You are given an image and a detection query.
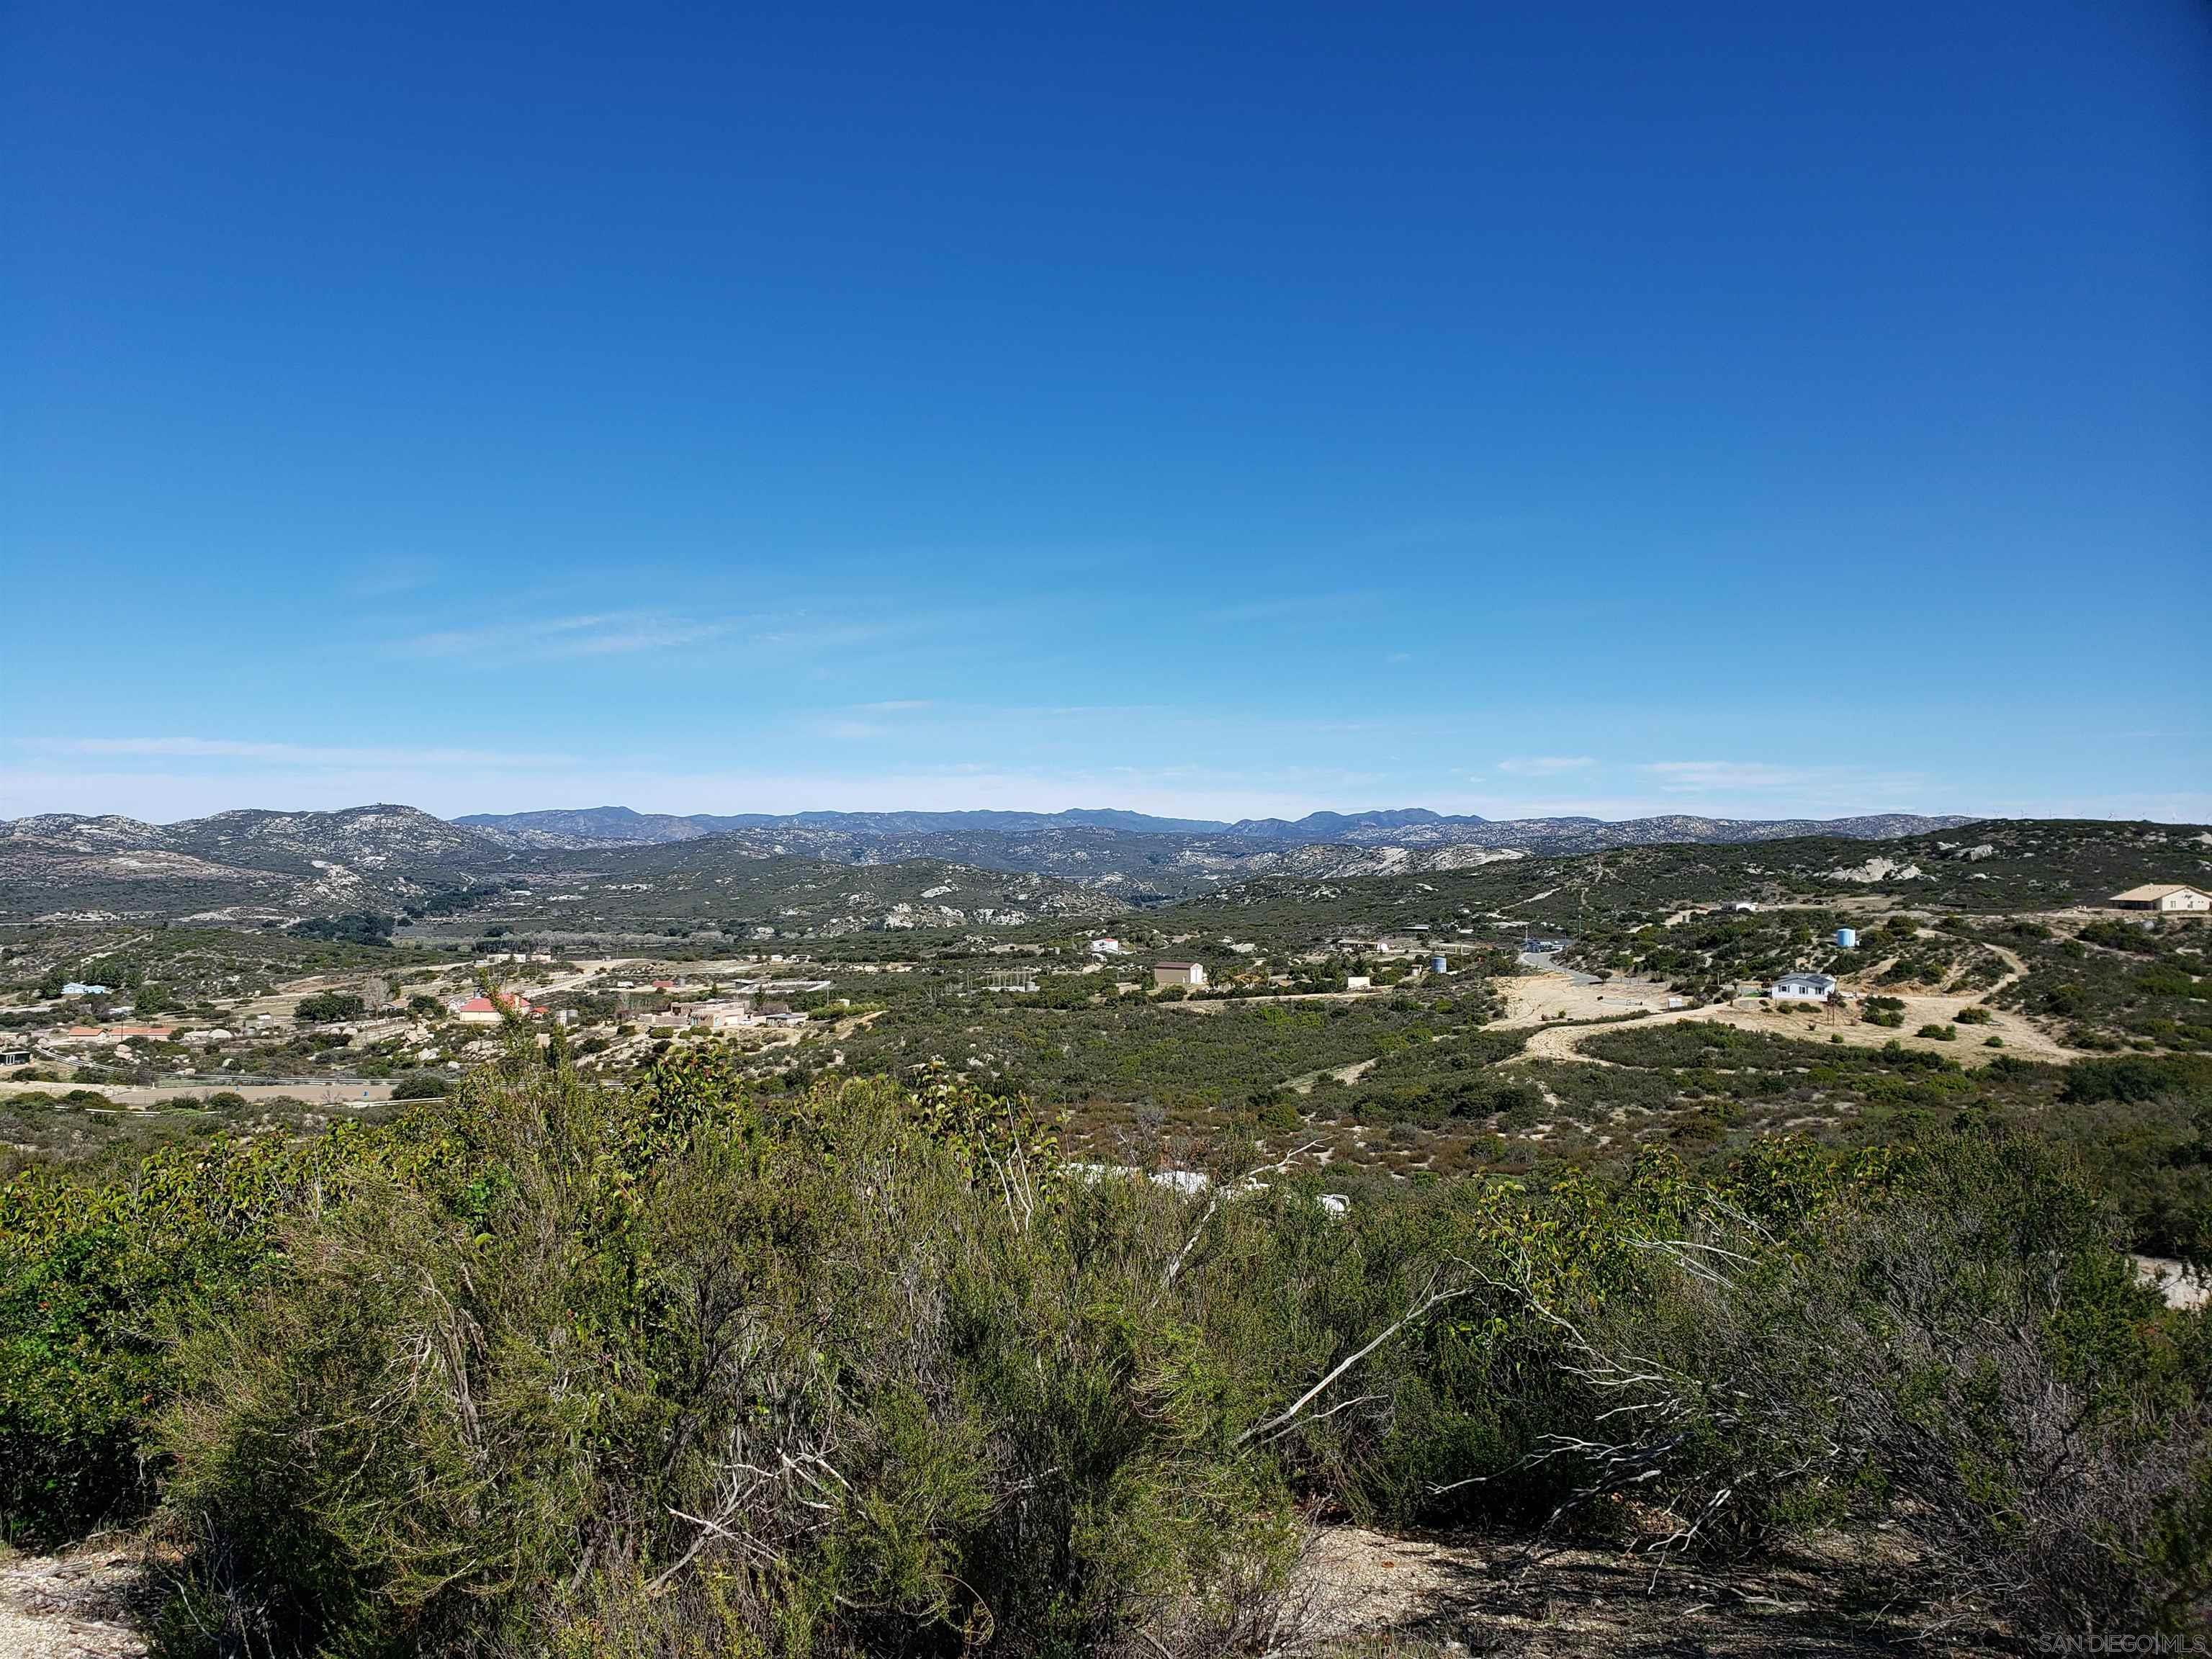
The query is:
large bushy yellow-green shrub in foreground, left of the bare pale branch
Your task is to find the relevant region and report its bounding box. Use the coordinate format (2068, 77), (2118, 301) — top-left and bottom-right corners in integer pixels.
(161, 1062), (1294, 1655)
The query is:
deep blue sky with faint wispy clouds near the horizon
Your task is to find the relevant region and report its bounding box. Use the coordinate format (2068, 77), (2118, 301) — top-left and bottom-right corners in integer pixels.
(0, 0), (2212, 819)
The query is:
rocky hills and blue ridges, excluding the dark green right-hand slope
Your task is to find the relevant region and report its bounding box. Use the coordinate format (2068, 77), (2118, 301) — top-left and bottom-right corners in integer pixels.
(0, 805), (1966, 922)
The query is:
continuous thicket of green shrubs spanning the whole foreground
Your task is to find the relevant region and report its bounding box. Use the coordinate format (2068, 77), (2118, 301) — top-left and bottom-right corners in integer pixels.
(0, 1043), (2212, 1659)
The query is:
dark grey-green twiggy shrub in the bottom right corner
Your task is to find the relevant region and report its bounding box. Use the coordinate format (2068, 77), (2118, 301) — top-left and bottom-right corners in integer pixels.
(1513, 1135), (2212, 1630)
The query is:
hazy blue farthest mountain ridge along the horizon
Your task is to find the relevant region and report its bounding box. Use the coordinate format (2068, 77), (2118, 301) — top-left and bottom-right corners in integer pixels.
(454, 807), (1969, 850)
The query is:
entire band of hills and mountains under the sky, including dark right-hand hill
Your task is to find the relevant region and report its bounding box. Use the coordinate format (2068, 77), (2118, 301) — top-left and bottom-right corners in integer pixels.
(0, 805), (2212, 938)
